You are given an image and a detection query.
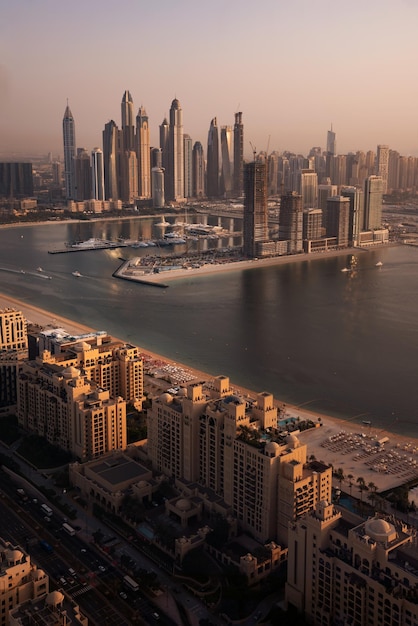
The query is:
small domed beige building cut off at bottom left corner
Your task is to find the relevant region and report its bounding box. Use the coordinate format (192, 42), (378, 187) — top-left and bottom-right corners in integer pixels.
(0, 539), (49, 626)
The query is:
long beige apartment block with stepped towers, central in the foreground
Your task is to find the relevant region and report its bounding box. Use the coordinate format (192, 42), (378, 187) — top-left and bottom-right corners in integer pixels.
(147, 376), (332, 545)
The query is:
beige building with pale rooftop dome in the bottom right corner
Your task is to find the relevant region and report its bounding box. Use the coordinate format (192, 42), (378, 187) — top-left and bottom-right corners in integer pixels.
(286, 501), (418, 626)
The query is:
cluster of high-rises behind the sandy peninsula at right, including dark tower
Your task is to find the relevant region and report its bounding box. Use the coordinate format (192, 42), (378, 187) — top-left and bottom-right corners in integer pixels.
(243, 131), (389, 257)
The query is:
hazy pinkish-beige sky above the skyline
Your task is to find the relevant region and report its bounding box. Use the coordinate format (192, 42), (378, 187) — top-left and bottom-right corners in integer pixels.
(0, 0), (418, 158)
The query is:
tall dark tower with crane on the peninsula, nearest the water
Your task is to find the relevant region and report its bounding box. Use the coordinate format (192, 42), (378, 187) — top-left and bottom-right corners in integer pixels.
(243, 161), (268, 258)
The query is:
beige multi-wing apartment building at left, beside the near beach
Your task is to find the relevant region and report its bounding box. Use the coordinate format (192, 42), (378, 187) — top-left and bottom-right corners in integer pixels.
(17, 330), (144, 461)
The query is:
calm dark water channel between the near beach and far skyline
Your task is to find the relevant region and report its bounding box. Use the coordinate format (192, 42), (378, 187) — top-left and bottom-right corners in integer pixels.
(0, 217), (418, 437)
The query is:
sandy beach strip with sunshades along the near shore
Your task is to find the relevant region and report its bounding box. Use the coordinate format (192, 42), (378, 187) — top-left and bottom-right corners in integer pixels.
(0, 294), (418, 494)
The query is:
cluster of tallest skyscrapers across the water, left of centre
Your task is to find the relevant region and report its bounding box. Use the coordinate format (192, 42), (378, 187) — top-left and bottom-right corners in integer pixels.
(63, 91), (244, 207)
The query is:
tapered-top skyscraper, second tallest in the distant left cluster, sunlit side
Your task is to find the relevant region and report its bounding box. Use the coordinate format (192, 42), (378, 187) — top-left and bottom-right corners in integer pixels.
(167, 98), (184, 202)
